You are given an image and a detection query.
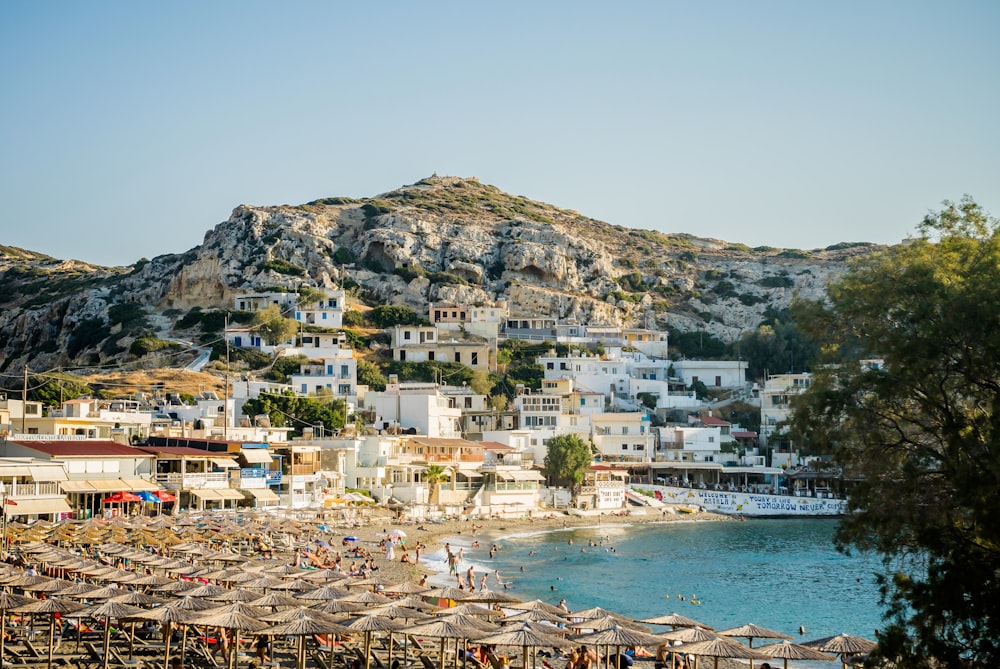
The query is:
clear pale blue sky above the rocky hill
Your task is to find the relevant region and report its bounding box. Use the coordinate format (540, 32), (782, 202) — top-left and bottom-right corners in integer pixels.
(0, 0), (1000, 264)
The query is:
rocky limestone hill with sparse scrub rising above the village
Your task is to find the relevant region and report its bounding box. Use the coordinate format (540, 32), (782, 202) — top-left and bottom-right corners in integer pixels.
(0, 175), (874, 373)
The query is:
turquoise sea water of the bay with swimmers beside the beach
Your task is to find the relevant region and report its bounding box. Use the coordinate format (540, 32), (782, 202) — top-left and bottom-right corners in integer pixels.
(435, 519), (881, 645)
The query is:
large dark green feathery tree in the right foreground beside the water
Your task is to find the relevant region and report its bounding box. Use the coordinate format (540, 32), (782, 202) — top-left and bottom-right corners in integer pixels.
(794, 198), (1000, 667)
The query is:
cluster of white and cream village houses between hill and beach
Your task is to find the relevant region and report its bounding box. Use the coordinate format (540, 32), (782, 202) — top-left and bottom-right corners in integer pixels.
(0, 290), (795, 517)
